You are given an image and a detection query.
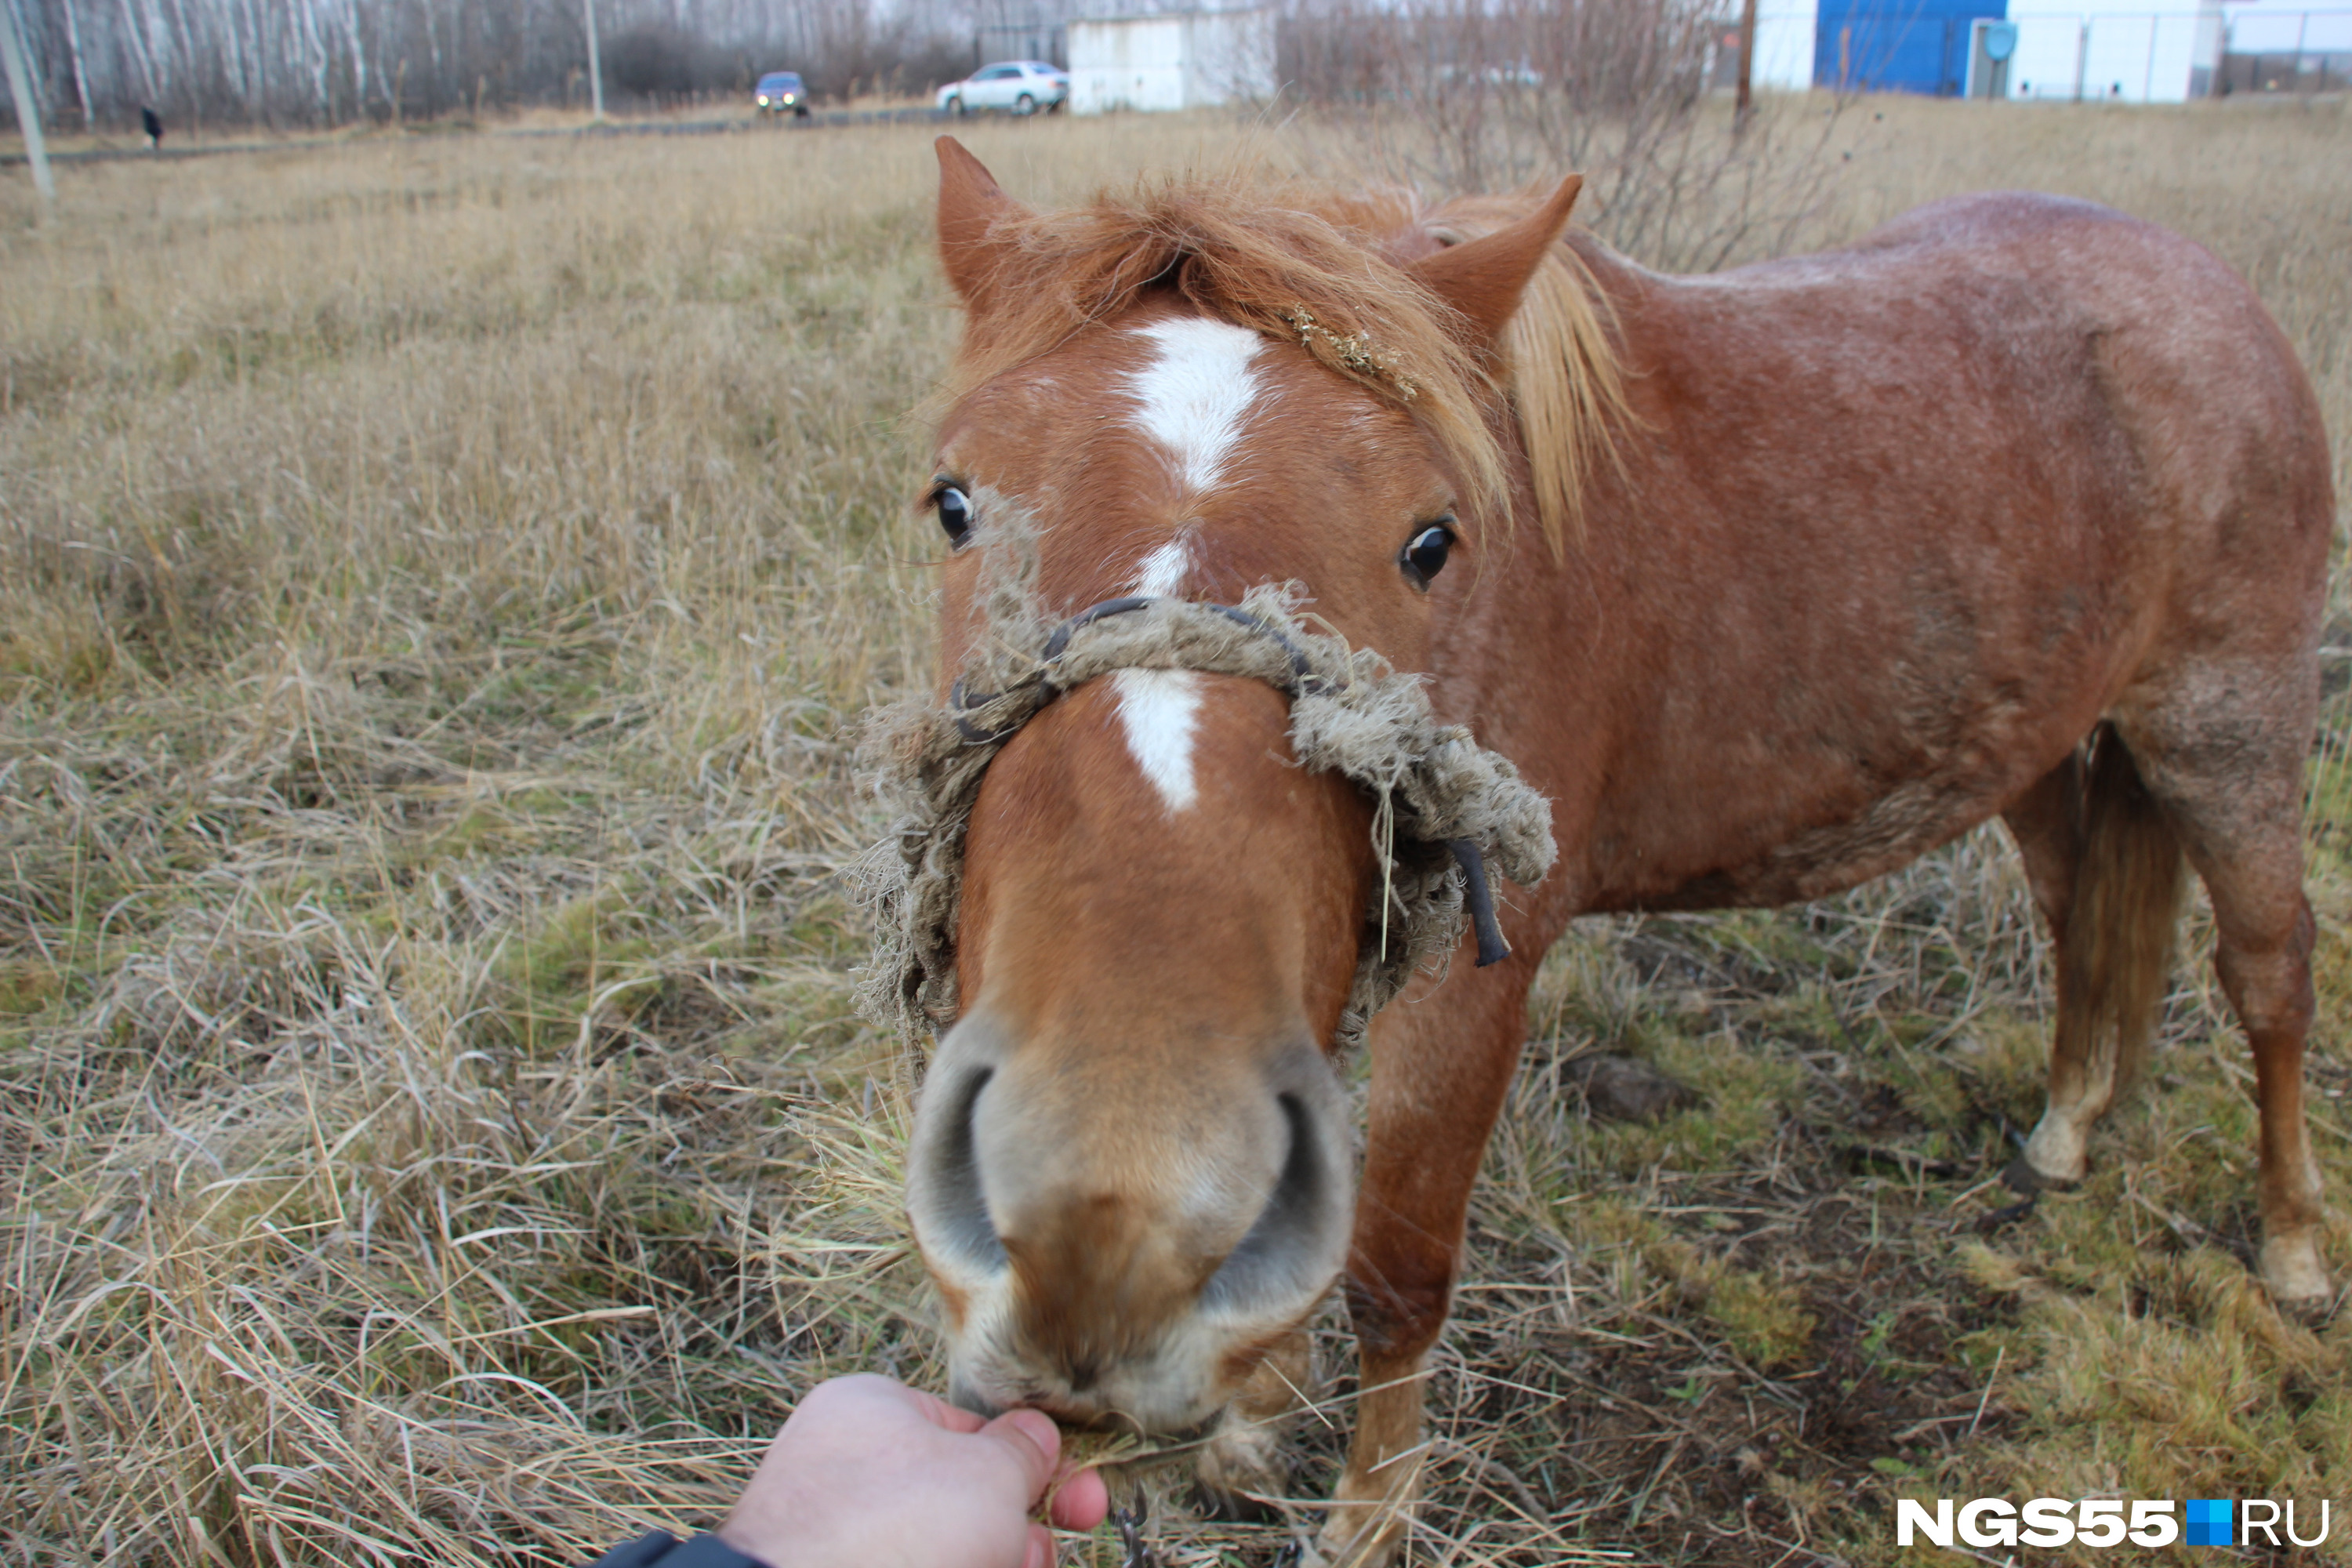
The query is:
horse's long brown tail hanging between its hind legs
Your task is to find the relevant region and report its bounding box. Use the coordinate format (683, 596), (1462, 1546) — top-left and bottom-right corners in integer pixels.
(2058, 724), (2185, 1093)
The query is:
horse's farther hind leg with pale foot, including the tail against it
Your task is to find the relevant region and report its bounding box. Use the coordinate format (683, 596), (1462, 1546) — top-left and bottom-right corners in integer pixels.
(2004, 727), (2183, 1189)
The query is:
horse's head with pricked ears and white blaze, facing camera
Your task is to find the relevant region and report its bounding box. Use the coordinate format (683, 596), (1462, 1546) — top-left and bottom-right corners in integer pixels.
(889, 139), (1576, 1432)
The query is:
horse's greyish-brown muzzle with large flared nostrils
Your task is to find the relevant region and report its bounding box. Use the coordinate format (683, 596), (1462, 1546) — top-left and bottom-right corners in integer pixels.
(908, 1011), (1352, 1434)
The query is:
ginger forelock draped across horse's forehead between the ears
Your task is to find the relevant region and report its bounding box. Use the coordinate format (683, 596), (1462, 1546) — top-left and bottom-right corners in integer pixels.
(943, 183), (1510, 535)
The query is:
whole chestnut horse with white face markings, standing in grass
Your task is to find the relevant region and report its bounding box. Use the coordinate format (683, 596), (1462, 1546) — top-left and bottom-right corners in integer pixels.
(884, 139), (2333, 1561)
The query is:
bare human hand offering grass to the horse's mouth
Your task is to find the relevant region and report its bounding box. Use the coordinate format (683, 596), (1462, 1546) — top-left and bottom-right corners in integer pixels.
(720, 1373), (1110, 1568)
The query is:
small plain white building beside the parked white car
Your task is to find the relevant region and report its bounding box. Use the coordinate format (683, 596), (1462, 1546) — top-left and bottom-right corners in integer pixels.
(1068, 9), (1277, 115)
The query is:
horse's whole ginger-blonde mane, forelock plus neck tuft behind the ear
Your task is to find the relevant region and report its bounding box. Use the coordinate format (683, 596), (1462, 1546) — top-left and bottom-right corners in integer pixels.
(943, 183), (1623, 550)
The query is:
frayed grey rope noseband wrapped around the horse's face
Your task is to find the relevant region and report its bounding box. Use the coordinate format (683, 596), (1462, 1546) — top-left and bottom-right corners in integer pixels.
(849, 496), (1555, 1048)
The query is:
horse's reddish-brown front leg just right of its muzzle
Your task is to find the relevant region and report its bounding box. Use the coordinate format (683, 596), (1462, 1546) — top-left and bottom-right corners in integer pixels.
(1317, 942), (1543, 1568)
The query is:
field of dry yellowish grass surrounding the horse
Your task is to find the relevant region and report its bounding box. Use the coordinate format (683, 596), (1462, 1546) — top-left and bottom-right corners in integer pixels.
(0, 101), (2352, 1568)
